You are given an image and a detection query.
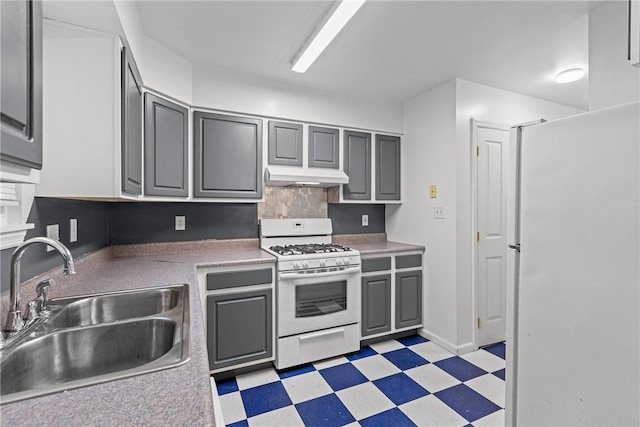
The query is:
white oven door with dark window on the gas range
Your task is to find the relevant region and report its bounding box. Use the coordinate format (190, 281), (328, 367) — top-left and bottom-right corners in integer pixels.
(278, 266), (361, 337)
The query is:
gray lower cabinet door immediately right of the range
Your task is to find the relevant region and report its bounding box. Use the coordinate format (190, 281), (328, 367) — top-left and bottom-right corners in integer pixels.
(362, 274), (391, 337)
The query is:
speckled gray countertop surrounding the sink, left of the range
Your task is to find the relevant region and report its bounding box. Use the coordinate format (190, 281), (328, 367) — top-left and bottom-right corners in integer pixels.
(0, 239), (275, 426)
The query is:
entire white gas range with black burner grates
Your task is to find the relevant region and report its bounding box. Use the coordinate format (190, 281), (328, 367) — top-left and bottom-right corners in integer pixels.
(260, 218), (361, 369)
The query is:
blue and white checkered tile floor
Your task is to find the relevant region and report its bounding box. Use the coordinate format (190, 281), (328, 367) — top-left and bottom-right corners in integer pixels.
(211, 335), (505, 427)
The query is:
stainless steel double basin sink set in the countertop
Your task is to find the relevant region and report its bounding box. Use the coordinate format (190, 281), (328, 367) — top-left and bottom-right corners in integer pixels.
(0, 285), (190, 404)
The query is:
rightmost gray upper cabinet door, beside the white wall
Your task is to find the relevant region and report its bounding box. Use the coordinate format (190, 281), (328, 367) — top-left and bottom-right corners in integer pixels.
(376, 135), (400, 200)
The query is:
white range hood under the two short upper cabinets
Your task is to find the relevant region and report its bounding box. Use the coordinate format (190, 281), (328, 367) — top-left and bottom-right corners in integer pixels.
(264, 166), (349, 187)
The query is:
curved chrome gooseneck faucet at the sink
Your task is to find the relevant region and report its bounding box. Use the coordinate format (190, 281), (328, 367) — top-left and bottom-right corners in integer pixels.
(2, 237), (76, 335)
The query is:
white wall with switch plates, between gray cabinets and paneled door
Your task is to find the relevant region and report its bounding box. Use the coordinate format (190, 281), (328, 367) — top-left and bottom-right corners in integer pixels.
(387, 79), (580, 352)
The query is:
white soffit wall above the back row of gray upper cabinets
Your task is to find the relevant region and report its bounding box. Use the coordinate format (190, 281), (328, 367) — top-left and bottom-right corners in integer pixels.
(193, 64), (403, 133)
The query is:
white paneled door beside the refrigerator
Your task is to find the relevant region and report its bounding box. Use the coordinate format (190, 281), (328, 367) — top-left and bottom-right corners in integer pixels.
(475, 125), (509, 346)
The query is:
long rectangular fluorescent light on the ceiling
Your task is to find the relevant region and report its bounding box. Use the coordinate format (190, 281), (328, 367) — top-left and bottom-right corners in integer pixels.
(291, 0), (365, 73)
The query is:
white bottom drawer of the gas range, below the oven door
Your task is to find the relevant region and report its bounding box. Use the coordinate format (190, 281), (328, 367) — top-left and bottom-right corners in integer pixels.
(276, 323), (360, 369)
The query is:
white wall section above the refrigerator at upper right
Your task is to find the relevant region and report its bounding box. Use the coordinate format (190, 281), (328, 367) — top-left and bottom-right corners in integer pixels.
(589, 1), (640, 111)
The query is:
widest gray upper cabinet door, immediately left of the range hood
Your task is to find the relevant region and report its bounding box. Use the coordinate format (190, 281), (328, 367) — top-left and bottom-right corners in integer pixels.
(193, 111), (262, 199)
